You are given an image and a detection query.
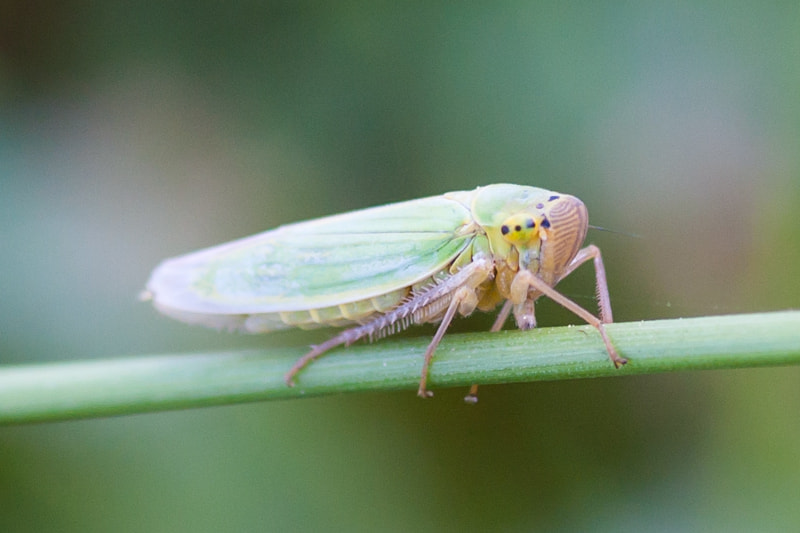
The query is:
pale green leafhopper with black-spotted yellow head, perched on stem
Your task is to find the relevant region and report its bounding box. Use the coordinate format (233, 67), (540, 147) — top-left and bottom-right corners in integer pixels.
(146, 184), (626, 402)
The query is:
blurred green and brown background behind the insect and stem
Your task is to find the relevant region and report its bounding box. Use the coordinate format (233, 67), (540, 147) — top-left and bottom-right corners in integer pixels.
(0, 1), (800, 532)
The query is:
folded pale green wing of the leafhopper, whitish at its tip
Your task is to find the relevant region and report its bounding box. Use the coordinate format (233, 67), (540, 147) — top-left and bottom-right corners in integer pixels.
(147, 196), (474, 314)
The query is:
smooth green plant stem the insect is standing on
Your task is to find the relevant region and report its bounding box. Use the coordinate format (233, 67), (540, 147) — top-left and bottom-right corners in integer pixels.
(0, 311), (800, 423)
